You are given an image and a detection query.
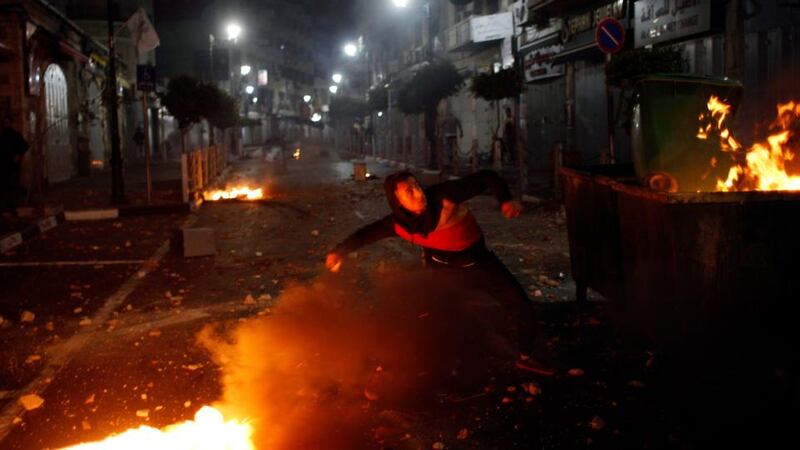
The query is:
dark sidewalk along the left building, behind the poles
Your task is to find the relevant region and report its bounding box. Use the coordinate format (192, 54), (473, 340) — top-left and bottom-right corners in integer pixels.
(30, 161), (182, 211)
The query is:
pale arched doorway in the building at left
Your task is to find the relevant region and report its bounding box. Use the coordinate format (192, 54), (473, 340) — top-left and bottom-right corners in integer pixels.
(44, 64), (74, 183)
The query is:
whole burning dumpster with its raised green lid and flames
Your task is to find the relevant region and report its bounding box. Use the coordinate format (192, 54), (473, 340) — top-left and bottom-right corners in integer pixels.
(562, 79), (800, 367)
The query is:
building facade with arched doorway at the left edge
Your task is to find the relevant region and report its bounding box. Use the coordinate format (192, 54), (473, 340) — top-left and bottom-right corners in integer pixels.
(0, 0), (108, 192)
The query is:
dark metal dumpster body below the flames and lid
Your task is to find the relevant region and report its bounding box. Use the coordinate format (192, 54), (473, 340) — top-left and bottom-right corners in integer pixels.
(562, 167), (800, 367)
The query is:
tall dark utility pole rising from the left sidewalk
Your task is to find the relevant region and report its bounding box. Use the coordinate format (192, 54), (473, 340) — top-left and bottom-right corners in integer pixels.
(106, 0), (125, 205)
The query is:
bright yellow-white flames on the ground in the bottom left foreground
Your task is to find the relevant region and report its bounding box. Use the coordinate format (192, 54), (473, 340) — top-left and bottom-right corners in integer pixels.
(63, 406), (255, 450)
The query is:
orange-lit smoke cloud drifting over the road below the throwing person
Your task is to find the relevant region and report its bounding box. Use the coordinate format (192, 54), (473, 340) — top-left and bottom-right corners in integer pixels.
(198, 270), (513, 450)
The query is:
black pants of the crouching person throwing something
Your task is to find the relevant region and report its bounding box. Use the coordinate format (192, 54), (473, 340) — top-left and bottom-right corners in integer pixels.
(425, 247), (541, 355)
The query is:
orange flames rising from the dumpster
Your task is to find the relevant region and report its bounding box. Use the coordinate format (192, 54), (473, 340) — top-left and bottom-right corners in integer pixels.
(697, 96), (800, 192)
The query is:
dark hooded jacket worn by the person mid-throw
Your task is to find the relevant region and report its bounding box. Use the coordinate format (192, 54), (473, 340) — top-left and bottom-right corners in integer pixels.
(333, 170), (512, 255)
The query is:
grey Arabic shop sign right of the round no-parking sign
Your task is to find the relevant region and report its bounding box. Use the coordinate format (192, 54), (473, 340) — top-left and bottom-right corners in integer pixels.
(633, 0), (711, 48)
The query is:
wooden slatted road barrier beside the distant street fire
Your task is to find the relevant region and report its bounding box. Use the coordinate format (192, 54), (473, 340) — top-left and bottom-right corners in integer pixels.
(181, 145), (228, 203)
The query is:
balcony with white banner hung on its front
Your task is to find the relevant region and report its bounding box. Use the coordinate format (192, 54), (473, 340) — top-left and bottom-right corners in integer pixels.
(445, 12), (514, 52)
